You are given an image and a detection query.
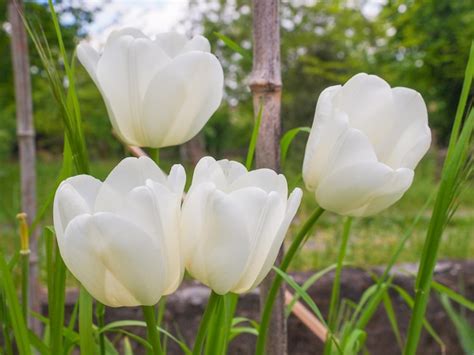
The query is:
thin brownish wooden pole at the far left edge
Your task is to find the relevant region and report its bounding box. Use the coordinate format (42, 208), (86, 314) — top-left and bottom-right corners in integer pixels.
(8, 0), (40, 333)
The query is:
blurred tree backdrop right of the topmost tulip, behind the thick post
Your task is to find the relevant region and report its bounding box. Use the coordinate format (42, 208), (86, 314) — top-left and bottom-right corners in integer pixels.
(185, 0), (474, 156)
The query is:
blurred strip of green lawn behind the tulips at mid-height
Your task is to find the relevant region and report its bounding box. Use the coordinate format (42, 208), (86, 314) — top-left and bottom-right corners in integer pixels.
(0, 149), (474, 270)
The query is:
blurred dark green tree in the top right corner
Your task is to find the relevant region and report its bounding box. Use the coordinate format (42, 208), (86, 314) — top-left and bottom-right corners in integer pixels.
(374, 0), (474, 143)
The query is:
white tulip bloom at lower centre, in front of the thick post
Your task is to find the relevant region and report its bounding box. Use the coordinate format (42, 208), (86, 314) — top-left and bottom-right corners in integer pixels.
(181, 157), (302, 294)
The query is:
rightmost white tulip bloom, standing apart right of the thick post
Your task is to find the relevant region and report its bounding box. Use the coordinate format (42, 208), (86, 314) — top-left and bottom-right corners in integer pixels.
(303, 74), (431, 216)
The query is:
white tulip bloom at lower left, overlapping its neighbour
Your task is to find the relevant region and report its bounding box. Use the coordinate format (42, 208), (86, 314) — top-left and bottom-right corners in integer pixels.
(54, 157), (186, 307)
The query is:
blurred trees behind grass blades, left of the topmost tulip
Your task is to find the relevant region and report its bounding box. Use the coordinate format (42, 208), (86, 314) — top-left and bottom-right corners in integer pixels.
(0, 0), (117, 158)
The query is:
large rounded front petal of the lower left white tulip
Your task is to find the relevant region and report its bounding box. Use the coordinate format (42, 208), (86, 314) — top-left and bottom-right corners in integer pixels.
(61, 213), (167, 307)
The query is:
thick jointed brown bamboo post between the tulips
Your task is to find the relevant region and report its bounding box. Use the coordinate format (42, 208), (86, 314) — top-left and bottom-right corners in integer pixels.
(250, 0), (287, 355)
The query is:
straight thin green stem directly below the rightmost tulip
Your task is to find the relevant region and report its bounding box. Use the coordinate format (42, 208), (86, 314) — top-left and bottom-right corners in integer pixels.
(324, 217), (352, 354)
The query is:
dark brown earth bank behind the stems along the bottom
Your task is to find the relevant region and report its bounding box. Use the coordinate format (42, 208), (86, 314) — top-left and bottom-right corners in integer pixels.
(40, 261), (474, 355)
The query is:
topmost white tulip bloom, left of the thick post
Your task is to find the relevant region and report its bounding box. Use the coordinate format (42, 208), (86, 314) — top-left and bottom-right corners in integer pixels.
(77, 28), (224, 148)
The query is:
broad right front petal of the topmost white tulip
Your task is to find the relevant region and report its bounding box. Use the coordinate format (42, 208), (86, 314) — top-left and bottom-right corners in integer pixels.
(143, 52), (224, 147)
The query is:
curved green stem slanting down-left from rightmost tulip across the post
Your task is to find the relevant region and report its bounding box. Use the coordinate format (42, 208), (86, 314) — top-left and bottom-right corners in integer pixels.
(255, 207), (324, 355)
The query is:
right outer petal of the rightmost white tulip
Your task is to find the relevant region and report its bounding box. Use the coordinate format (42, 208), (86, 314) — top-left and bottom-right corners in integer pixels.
(385, 88), (431, 169)
